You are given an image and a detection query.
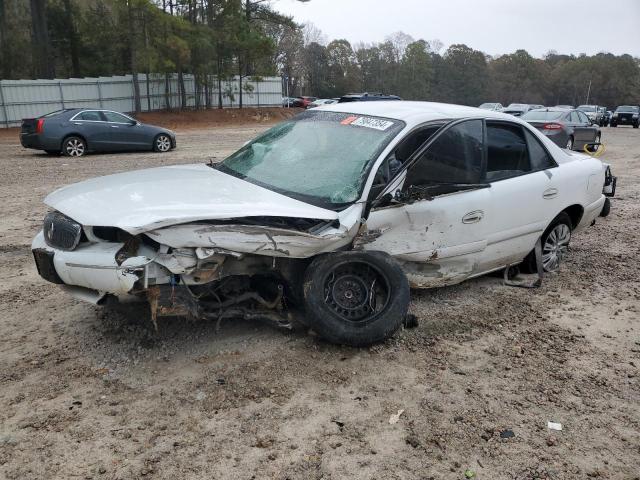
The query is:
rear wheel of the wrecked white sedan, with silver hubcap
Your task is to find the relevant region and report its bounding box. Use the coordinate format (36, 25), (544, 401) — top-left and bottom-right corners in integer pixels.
(520, 212), (573, 273)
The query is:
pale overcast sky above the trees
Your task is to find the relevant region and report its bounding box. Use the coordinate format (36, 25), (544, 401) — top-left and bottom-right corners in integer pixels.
(272, 0), (640, 57)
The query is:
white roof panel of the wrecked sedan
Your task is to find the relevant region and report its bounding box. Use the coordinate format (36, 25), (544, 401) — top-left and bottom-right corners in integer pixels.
(318, 100), (514, 126)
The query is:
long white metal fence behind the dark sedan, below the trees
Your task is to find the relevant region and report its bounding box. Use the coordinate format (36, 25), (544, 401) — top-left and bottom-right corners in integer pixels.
(0, 74), (282, 127)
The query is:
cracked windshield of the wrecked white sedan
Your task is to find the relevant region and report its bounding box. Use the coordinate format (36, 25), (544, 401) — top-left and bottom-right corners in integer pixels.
(218, 112), (404, 206)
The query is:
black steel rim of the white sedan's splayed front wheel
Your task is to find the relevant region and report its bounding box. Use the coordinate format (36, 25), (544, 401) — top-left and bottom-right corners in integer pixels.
(323, 261), (391, 323)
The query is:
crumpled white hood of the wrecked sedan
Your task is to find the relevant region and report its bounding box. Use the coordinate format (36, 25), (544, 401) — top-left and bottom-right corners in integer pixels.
(44, 164), (338, 234)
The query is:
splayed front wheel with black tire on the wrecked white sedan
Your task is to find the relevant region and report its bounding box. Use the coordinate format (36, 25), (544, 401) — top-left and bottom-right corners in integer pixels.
(304, 252), (410, 347)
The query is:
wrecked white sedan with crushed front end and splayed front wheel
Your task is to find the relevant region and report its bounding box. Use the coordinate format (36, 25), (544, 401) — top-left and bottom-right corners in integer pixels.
(32, 102), (612, 345)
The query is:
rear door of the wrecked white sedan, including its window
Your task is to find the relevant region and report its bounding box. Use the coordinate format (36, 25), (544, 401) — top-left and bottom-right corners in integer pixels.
(480, 121), (561, 272)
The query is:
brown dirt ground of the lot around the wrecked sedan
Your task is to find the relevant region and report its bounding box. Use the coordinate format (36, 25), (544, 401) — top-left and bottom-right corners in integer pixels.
(0, 115), (640, 480)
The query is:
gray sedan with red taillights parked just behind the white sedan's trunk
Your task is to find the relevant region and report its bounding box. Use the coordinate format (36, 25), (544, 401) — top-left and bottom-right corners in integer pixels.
(520, 108), (602, 150)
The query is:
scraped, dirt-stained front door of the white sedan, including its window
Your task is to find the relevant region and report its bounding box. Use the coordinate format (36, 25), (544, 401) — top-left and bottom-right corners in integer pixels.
(363, 119), (489, 287)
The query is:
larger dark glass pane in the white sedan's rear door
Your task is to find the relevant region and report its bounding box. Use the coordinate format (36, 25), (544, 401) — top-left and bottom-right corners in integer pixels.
(486, 124), (531, 182)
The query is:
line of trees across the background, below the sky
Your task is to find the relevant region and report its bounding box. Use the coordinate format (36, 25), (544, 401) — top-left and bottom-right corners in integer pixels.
(0, 0), (640, 108)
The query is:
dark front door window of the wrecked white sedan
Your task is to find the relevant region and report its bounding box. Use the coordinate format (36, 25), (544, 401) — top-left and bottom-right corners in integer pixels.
(405, 120), (483, 186)
